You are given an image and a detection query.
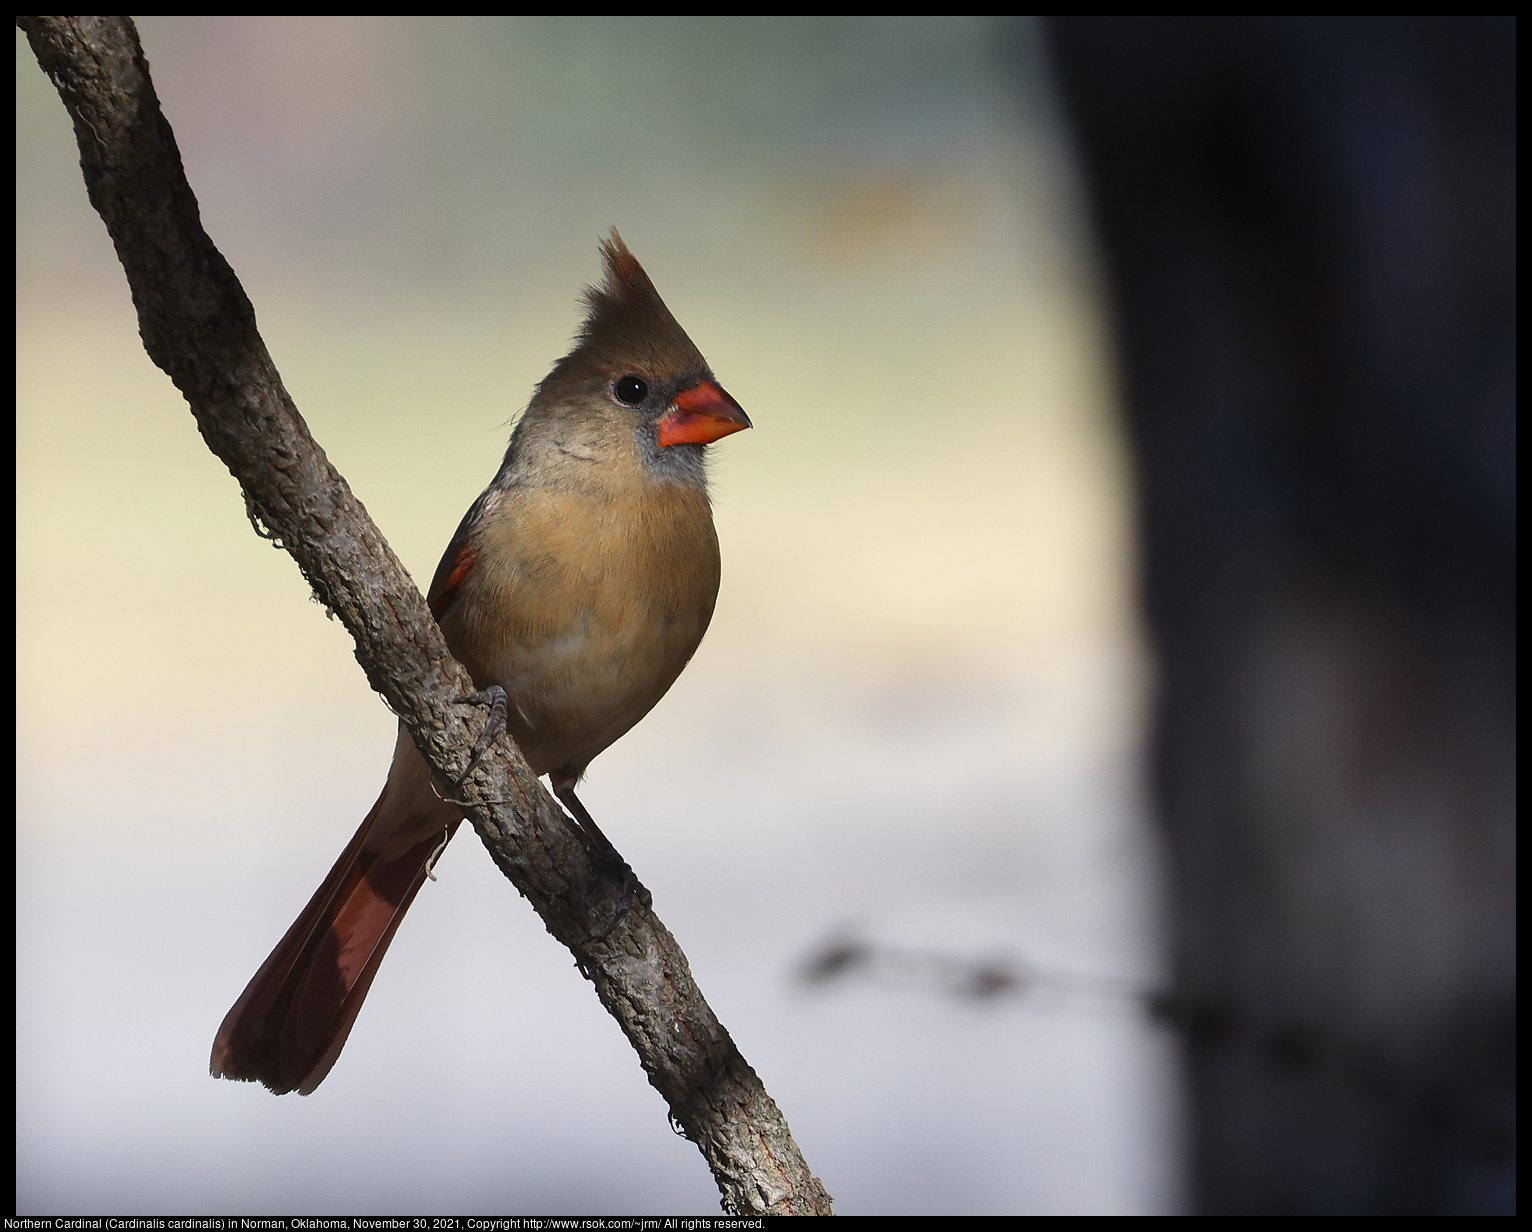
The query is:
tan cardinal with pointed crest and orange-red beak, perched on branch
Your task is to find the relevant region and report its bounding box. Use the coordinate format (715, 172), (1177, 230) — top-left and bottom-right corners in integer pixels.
(211, 230), (751, 1096)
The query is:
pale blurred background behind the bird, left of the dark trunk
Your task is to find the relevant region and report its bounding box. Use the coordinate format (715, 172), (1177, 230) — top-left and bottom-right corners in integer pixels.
(17, 17), (1184, 1215)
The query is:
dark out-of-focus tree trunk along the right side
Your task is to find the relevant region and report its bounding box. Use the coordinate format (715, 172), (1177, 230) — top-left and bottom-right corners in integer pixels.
(1048, 18), (1515, 1215)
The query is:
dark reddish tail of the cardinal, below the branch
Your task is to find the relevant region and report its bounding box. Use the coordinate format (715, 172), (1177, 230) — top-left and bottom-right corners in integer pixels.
(211, 788), (461, 1096)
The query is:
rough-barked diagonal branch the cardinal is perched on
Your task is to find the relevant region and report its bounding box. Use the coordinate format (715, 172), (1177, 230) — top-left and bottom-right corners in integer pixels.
(17, 17), (830, 1214)
